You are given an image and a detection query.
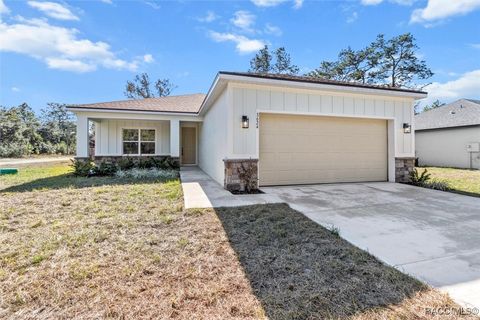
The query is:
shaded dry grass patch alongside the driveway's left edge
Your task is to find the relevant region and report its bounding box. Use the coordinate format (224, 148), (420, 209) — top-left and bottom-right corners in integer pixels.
(217, 204), (473, 320)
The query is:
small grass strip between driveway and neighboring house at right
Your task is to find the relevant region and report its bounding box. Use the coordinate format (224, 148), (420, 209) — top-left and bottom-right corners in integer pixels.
(418, 167), (480, 197)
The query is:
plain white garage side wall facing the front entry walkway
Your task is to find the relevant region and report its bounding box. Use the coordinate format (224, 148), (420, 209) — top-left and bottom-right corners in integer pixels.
(198, 90), (230, 185)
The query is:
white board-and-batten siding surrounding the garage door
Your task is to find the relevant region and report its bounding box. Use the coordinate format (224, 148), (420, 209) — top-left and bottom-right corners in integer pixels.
(229, 83), (414, 158)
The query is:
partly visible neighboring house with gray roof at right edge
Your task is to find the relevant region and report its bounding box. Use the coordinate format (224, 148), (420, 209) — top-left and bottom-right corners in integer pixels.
(415, 99), (480, 169)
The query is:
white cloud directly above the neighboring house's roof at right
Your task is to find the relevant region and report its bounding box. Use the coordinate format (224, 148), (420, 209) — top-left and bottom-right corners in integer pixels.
(421, 69), (480, 105)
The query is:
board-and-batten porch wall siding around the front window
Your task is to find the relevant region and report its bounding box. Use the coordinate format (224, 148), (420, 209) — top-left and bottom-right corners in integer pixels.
(95, 119), (170, 156)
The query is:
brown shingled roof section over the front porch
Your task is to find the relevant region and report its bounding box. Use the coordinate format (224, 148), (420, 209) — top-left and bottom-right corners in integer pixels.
(68, 93), (205, 114)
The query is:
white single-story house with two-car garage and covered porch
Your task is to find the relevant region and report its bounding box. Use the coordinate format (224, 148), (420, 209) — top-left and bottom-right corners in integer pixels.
(69, 72), (427, 190)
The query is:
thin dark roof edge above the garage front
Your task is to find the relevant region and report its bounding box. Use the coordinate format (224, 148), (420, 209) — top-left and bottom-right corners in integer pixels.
(219, 71), (427, 94)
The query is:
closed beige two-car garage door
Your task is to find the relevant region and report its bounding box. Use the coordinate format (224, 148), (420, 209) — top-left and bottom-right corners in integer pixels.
(259, 114), (387, 186)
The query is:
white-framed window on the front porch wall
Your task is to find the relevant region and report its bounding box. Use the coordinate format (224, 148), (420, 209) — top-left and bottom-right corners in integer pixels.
(122, 129), (155, 154)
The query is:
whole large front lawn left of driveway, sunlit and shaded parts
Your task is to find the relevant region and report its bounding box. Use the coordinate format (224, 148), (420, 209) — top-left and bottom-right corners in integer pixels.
(0, 164), (471, 320)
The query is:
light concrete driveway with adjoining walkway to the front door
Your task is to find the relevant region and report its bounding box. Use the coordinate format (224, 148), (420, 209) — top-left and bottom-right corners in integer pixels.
(181, 168), (480, 308)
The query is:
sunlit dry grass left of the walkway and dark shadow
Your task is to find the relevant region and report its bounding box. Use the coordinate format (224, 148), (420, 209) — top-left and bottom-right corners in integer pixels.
(0, 167), (262, 319)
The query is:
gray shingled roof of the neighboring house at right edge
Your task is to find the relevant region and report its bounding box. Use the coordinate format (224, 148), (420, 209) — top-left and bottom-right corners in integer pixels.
(415, 99), (480, 130)
